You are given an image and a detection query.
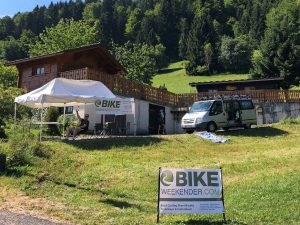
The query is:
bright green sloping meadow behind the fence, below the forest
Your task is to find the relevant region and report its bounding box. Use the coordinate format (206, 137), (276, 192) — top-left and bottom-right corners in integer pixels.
(152, 61), (249, 93)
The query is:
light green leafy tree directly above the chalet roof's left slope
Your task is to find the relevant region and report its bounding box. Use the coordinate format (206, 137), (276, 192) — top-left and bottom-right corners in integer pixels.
(29, 19), (97, 56)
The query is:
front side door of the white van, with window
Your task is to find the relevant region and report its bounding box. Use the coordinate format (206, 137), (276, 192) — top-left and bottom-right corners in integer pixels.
(209, 101), (227, 127)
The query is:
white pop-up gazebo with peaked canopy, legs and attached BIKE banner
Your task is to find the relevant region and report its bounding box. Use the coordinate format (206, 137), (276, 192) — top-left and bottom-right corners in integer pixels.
(15, 78), (134, 140)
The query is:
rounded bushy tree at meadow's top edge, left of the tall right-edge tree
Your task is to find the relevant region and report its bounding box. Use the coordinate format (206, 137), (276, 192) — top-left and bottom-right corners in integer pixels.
(219, 36), (251, 72)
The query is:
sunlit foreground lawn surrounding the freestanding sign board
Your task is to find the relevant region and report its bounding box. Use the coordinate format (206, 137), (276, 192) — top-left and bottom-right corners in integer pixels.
(0, 120), (300, 225)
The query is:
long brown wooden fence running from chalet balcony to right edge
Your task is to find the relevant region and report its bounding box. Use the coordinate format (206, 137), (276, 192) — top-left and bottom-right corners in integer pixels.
(60, 68), (300, 107)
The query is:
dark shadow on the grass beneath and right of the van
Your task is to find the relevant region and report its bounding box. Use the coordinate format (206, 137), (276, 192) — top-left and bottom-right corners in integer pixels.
(218, 127), (288, 137)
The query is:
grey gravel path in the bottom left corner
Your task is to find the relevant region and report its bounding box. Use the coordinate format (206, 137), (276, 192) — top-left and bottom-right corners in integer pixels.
(0, 210), (66, 225)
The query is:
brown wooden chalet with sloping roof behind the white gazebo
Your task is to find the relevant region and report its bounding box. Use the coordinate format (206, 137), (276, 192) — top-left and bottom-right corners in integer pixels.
(8, 44), (126, 91)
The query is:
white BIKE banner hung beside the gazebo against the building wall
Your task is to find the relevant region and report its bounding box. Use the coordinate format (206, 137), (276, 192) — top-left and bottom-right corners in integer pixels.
(95, 98), (134, 115)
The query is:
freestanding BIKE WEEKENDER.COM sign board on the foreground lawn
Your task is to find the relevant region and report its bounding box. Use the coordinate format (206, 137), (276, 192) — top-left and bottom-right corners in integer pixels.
(158, 168), (224, 214)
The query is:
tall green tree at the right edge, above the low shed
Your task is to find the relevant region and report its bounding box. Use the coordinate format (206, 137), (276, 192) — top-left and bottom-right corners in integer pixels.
(251, 0), (300, 87)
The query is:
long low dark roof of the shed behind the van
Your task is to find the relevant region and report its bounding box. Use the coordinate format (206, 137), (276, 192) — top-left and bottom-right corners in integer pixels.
(189, 77), (284, 87)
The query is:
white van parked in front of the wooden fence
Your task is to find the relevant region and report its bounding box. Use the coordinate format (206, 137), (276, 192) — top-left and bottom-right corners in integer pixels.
(181, 97), (256, 133)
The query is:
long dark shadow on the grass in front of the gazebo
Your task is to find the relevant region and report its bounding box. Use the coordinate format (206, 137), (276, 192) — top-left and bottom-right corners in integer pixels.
(65, 137), (162, 151)
